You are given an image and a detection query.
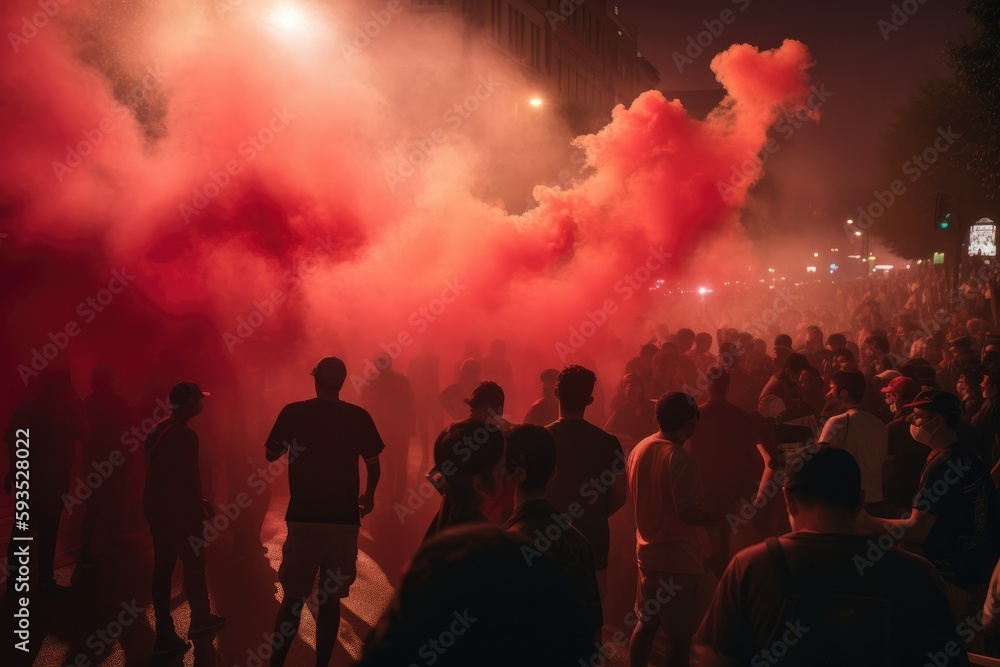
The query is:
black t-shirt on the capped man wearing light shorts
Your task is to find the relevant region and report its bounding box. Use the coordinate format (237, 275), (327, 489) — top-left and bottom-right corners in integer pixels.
(265, 398), (385, 526)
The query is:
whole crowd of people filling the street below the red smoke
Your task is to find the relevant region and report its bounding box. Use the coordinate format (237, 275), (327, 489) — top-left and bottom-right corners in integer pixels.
(5, 271), (1000, 667)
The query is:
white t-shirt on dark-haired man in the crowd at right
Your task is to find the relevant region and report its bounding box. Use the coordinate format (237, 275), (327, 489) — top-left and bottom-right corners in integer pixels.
(819, 408), (889, 503)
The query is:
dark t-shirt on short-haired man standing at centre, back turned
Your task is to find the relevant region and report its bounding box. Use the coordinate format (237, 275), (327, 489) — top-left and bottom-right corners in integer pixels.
(546, 419), (625, 570)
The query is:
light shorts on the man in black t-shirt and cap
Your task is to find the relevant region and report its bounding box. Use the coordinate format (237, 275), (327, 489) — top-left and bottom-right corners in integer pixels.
(278, 521), (358, 600)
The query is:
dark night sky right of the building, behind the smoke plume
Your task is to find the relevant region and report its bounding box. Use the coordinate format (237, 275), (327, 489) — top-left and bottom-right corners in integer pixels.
(619, 0), (971, 239)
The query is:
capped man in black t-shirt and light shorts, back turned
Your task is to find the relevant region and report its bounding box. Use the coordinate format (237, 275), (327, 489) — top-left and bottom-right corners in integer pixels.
(265, 357), (385, 667)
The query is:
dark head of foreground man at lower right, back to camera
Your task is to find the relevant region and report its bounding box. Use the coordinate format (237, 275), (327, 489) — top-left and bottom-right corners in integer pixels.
(784, 447), (864, 532)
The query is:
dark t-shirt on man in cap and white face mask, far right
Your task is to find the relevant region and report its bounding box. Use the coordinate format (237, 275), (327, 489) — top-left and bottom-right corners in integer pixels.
(913, 442), (1000, 586)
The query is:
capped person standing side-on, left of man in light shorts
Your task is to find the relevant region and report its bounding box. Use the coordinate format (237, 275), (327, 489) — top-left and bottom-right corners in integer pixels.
(142, 382), (226, 655)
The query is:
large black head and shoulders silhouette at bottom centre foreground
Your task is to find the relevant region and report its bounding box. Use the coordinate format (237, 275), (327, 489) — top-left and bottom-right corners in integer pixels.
(357, 525), (596, 667)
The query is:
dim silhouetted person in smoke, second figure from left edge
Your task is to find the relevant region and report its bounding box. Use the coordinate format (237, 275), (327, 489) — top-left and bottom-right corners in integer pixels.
(80, 365), (132, 567)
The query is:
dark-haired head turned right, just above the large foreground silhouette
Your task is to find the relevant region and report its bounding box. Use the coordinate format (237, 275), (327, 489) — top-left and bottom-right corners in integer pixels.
(434, 419), (506, 508)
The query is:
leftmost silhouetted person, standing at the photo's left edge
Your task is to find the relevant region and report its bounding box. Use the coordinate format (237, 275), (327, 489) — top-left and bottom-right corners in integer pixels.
(4, 370), (88, 596)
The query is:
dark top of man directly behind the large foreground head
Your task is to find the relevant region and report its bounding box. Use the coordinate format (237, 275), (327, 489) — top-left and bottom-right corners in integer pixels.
(504, 499), (604, 632)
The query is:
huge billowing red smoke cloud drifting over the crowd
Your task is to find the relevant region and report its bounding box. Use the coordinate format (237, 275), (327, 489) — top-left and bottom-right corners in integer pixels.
(0, 0), (811, 421)
